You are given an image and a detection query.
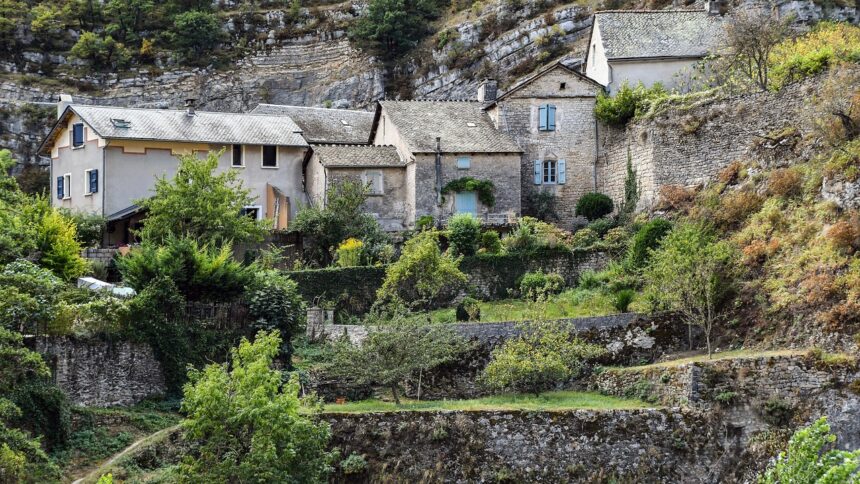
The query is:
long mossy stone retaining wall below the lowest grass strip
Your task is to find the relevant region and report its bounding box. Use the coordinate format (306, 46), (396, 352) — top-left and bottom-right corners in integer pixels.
(324, 409), (744, 483)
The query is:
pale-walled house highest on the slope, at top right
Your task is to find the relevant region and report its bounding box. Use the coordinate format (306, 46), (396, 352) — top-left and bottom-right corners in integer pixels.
(584, 1), (725, 94)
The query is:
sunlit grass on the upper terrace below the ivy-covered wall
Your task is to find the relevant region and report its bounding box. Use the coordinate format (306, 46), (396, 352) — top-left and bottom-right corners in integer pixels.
(430, 288), (645, 323)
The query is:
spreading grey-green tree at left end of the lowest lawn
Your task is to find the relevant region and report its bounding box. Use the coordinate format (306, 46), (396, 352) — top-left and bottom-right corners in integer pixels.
(327, 313), (470, 405)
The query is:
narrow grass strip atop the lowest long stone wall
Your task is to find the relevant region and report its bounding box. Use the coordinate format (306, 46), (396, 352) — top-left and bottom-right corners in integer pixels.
(325, 391), (654, 413)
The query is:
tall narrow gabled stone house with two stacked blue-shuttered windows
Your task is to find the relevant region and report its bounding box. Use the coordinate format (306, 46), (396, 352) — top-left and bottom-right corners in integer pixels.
(488, 62), (603, 226)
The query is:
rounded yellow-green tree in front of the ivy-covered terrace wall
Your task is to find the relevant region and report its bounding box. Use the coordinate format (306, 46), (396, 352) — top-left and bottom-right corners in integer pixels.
(377, 230), (467, 308)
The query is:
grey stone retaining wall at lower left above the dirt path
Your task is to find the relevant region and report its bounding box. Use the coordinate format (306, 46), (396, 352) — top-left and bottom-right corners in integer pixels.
(28, 337), (165, 407)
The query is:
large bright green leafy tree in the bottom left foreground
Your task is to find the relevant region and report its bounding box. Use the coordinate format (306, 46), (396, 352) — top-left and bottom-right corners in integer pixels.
(179, 331), (333, 482)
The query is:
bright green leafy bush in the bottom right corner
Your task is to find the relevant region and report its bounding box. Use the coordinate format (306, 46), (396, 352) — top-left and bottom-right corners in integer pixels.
(758, 417), (860, 484)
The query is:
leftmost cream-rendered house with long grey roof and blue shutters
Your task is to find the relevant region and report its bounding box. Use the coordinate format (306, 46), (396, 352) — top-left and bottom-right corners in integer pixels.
(39, 100), (308, 245)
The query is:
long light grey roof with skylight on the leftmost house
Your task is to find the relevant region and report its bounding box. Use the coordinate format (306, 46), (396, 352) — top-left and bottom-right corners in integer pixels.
(69, 104), (308, 146)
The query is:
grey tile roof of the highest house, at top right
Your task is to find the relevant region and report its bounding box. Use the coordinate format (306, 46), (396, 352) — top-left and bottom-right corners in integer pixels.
(594, 10), (724, 59)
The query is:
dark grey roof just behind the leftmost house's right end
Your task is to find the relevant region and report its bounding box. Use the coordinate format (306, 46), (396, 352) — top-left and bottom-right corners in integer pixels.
(251, 104), (373, 144)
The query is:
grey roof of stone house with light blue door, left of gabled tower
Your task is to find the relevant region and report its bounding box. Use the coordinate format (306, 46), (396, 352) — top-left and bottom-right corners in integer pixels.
(379, 101), (522, 153)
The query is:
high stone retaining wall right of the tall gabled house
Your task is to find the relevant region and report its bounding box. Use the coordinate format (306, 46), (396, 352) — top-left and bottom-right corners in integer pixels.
(597, 78), (821, 210)
